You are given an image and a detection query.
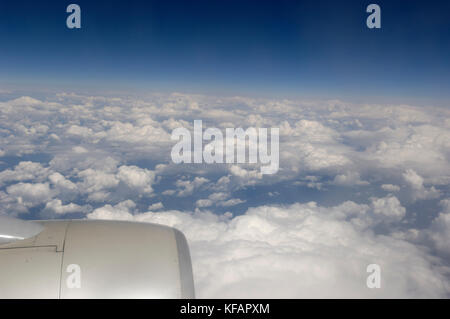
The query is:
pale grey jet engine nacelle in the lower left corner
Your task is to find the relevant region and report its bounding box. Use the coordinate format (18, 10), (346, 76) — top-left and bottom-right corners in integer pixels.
(0, 220), (194, 299)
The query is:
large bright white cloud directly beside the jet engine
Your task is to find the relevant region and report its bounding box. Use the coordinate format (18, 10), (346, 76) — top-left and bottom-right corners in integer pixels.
(89, 199), (450, 298)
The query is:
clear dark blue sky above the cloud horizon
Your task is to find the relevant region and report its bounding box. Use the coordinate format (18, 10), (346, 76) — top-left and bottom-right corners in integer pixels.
(0, 0), (450, 100)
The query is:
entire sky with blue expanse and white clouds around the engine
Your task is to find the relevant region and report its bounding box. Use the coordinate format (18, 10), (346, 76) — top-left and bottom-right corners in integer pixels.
(0, 1), (450, 298)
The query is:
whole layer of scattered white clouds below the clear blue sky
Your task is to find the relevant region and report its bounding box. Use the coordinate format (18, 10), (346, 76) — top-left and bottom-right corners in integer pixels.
(0, 93), (450, 298)
